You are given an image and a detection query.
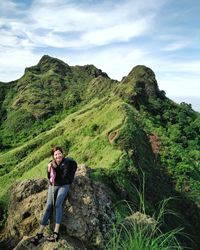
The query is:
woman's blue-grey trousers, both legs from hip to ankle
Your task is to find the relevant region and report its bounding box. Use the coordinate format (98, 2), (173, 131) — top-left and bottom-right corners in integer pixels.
(41, 185), (69, 226)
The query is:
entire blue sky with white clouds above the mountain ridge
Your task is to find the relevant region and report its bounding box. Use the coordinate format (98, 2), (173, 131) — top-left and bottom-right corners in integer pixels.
(0, 0), (200, 111)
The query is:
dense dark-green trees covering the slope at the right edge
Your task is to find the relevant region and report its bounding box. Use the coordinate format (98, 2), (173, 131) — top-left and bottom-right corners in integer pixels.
(143, 95), (200, 199)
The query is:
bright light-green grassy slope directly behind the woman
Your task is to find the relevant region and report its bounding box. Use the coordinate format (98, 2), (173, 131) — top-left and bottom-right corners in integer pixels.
(0, 94), (124, 196)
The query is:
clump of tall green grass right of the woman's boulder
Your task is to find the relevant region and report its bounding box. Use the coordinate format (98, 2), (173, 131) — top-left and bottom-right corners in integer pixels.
(105, 180), (186, 250)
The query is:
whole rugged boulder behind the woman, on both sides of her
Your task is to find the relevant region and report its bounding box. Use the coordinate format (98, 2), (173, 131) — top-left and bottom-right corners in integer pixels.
(0, 165), (115, 250)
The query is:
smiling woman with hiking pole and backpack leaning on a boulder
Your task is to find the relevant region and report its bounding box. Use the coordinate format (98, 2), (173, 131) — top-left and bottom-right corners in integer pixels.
(31, 147), (77, 245)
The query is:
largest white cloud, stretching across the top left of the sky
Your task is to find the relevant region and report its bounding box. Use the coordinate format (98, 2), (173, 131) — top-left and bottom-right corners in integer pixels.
(0, 0), (164, 48)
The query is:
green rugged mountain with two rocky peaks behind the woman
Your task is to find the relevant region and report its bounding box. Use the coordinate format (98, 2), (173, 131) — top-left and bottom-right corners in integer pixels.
(0, 55), (200, 249)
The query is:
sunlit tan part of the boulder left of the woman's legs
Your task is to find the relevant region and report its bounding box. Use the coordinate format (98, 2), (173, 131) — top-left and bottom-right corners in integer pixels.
(5, 179), (48, 249)
